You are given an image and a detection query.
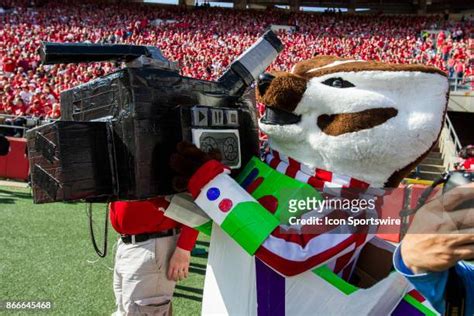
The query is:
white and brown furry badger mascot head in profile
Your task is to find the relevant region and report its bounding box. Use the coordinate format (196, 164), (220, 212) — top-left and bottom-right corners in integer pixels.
(257, 56), (449, 187)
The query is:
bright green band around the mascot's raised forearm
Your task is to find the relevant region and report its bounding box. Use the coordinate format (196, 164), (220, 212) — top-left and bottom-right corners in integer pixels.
(221, 202), (280, 255)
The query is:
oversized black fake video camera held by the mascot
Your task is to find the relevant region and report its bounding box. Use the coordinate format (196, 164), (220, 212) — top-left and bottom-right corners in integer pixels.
(27, 31), (282, 203)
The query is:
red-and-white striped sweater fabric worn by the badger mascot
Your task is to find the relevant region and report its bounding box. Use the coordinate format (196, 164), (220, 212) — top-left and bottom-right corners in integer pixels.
(255, 150), (383, 279)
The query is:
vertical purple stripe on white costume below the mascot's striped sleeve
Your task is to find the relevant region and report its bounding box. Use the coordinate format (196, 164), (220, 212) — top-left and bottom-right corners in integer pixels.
(255, 258), (285, 316)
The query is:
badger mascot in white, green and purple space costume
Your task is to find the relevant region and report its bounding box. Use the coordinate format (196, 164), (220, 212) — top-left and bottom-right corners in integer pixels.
(167, 56), (448, 316)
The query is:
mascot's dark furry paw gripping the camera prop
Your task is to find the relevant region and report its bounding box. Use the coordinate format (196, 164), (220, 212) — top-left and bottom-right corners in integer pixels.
(170, 141), (222, 192)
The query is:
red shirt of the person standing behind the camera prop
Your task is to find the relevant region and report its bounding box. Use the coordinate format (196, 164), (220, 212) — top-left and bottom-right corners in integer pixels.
(110, 197), (198, 251)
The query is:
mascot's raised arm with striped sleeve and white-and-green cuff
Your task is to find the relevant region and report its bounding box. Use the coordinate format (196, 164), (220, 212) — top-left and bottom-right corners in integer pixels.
(188, 160), (367, 276)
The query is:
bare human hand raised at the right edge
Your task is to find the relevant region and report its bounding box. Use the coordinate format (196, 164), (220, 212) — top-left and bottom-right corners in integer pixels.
(400, 183), (474, 274)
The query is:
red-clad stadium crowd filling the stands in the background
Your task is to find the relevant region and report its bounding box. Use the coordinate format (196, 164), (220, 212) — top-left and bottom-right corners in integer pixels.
(0, 1), (474, 124)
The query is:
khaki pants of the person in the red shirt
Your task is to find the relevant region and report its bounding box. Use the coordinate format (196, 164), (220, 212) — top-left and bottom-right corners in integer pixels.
(113, 235), (178, 316)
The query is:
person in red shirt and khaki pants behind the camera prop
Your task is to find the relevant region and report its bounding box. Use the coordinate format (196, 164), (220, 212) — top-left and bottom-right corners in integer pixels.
(110, 197), (198, 316)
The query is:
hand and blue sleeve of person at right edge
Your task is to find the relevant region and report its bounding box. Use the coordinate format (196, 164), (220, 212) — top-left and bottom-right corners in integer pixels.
(394, 183), (474, 315)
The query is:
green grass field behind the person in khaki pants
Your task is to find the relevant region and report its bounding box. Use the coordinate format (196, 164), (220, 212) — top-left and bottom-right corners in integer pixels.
(0, 186), (208, 315)
